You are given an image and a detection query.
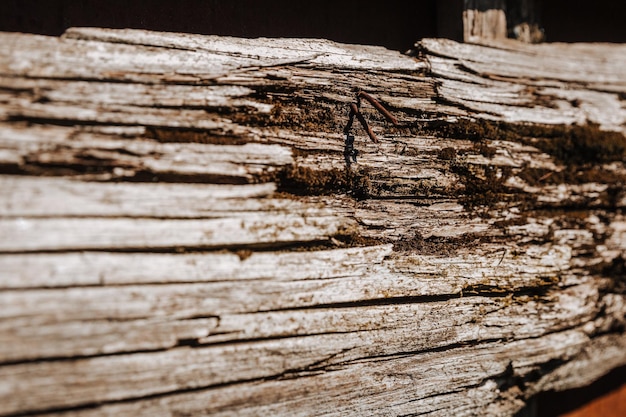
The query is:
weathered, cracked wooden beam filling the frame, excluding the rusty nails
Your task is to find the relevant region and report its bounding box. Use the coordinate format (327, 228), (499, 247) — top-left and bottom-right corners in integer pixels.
(0, 28), (626, 416)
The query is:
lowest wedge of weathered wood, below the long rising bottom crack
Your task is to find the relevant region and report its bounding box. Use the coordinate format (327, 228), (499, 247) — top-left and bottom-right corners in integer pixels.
(22, 330), (624, 415)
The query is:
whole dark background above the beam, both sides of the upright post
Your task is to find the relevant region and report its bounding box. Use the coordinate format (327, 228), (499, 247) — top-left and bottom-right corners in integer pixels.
(0, 0), (626, 51)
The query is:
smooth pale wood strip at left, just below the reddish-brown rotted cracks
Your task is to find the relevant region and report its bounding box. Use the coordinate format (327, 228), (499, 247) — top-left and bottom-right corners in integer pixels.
(0, 175), (310, 219)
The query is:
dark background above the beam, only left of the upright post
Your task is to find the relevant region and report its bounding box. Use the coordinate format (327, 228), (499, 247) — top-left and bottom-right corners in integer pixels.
(0, 0), (437, 50)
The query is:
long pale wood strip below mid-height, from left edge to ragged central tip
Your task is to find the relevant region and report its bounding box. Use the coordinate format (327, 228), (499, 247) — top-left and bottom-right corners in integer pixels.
(0, 245), (390, 289)
